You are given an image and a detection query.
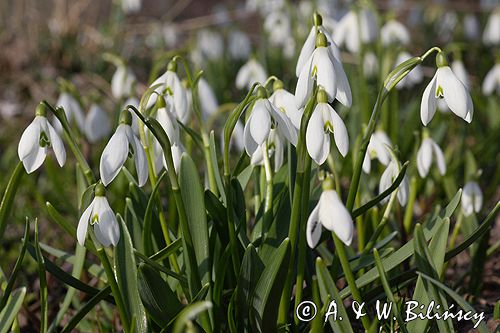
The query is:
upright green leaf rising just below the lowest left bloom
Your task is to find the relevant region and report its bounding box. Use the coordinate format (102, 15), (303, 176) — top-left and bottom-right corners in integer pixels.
(113, 215), (148, 332)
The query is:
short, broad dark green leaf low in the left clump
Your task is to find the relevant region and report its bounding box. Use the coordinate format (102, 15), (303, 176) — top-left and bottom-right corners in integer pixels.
(138, 264), (182, 327)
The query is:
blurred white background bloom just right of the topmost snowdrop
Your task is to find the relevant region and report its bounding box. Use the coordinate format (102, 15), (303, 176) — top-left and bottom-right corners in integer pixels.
(333, 9), (378, 53)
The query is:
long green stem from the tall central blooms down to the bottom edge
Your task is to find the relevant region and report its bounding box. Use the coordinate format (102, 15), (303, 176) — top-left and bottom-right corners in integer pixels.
(278, 88), (318, 326)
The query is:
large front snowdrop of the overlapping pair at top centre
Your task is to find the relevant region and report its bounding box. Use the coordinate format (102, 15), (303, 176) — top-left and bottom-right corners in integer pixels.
(295, 33), (352, 108)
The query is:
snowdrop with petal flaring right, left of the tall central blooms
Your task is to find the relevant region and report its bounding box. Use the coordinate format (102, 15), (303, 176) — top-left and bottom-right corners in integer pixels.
(243, 86), (297, 156)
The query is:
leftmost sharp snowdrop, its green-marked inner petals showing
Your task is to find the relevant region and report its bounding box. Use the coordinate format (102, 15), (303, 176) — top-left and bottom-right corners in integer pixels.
(17, 104), (66, 173)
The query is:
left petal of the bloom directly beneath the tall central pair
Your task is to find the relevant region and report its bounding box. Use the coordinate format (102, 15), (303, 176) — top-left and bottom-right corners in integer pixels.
(306, 103), (330, 165)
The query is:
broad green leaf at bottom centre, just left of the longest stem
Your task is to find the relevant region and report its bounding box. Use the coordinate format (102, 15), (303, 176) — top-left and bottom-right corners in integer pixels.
(251, 238), (290, 331)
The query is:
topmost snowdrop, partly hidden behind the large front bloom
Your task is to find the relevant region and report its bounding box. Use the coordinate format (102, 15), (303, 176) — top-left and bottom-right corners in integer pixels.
(295, 14), (341, 77)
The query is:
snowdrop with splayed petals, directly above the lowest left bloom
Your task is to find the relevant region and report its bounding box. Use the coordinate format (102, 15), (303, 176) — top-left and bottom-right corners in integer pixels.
(99, 110), (148, 187)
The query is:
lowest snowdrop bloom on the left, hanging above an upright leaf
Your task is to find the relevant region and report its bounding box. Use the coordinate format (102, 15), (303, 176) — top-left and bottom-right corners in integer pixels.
(76, 183), (120, 247)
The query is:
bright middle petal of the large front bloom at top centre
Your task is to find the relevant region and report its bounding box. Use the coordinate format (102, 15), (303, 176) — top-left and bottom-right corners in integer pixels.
(312, 47), (337, 103)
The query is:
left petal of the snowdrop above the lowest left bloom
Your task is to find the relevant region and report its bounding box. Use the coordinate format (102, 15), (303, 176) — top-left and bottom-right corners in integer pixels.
(99, 124), (128, 186)
